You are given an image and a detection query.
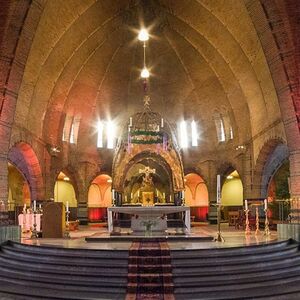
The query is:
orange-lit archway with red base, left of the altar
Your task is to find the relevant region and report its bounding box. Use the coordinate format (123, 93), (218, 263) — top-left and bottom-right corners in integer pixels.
(88, 174), (112, 222)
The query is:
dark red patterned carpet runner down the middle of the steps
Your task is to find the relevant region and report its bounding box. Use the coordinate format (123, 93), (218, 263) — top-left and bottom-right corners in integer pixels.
(126, 240), (175, 300)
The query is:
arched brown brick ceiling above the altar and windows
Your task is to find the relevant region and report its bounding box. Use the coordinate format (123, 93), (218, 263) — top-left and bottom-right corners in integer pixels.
(15, 0), (280, 161)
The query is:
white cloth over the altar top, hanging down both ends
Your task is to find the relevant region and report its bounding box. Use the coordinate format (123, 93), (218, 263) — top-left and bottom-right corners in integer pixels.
(107, 206), (191, 233)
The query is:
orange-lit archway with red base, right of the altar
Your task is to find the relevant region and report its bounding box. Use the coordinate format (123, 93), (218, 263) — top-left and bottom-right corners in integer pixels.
(184, 173), (209, 222)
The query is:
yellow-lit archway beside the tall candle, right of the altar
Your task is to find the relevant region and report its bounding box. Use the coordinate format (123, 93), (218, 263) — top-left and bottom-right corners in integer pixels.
(221, 170), (243, 220)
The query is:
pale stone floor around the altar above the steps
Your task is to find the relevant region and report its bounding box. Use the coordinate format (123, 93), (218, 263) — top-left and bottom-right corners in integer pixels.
(22, 223), (277, 250)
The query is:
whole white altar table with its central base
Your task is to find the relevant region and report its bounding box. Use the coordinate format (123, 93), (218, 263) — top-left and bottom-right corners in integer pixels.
(107, 206), (191, 233)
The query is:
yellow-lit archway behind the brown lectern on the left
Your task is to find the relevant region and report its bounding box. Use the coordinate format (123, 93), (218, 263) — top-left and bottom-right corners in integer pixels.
(54, 172), (77, 220)
